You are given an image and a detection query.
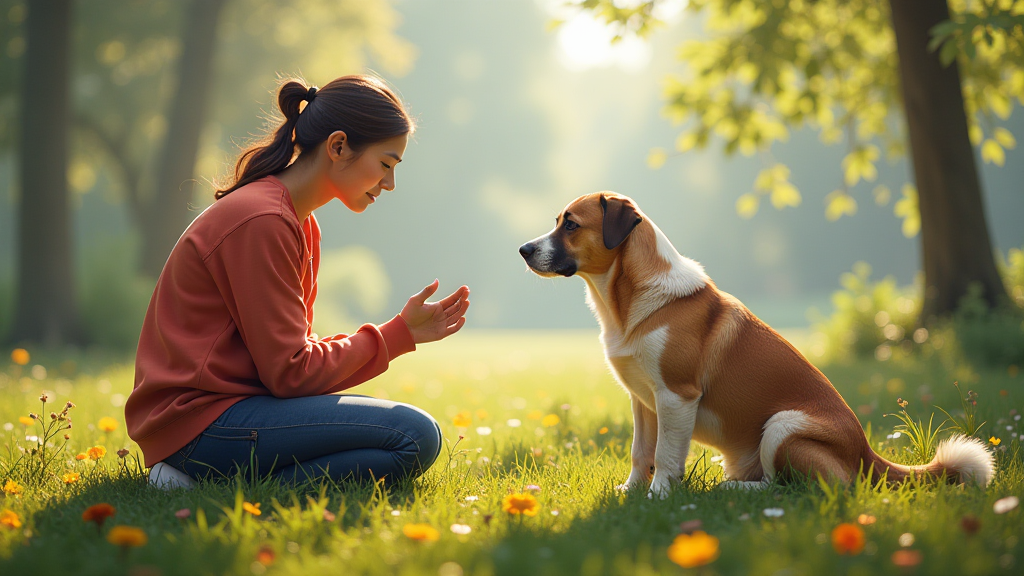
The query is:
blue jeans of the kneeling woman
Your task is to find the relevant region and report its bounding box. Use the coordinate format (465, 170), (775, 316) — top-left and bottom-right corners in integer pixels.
(164, 395), (441, 484)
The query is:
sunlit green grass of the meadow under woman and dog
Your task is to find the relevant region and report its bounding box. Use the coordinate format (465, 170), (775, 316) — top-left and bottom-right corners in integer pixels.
(0, 332), (1024, 576)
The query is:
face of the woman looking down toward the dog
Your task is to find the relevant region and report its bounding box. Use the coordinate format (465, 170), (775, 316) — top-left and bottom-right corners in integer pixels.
(329, 134), (409, 212)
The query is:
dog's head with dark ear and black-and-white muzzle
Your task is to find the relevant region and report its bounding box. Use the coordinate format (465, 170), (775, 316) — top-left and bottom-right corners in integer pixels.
(519, 192), (643, 278)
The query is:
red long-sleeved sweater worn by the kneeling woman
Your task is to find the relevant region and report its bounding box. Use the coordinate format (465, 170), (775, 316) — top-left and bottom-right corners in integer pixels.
(125, 176), (416, 466)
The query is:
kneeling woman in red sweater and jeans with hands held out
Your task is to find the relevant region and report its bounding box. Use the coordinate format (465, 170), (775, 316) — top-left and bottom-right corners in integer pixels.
(125, 76), (469, 488)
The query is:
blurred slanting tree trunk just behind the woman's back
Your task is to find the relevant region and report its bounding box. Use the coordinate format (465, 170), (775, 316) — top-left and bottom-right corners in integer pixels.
(140, 0), (225, 278)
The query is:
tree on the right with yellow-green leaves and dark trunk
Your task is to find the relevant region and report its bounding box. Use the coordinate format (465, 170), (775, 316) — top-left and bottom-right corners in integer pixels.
(581, 0), (1024, 321)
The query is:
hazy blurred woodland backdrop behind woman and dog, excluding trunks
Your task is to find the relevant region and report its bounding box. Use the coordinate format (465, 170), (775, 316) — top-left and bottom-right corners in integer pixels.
(0, 0), (1024, 362)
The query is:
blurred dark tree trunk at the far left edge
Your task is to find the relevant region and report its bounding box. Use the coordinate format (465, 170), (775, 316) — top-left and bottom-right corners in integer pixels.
(11, 0), (80, 345)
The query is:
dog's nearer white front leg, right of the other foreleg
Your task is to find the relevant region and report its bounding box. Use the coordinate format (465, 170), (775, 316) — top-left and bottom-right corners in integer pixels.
(650, 387), (700, 498)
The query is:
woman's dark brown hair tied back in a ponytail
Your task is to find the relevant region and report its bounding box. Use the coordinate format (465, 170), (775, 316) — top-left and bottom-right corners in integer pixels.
(213, 75), (416, 200)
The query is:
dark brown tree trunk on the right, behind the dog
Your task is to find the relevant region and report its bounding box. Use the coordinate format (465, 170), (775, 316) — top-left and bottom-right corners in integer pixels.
(890, 0), (1006, 322)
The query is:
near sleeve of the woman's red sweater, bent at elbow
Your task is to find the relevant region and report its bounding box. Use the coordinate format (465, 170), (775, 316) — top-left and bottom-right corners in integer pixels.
(206, 214), (416, 398)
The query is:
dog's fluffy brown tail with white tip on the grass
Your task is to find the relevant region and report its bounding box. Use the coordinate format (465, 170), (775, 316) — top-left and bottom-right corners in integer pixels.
(870, 435), (995, 487)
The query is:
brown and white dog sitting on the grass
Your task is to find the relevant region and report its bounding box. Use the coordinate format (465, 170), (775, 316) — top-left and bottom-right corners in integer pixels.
(519, 192), (994, 497)
